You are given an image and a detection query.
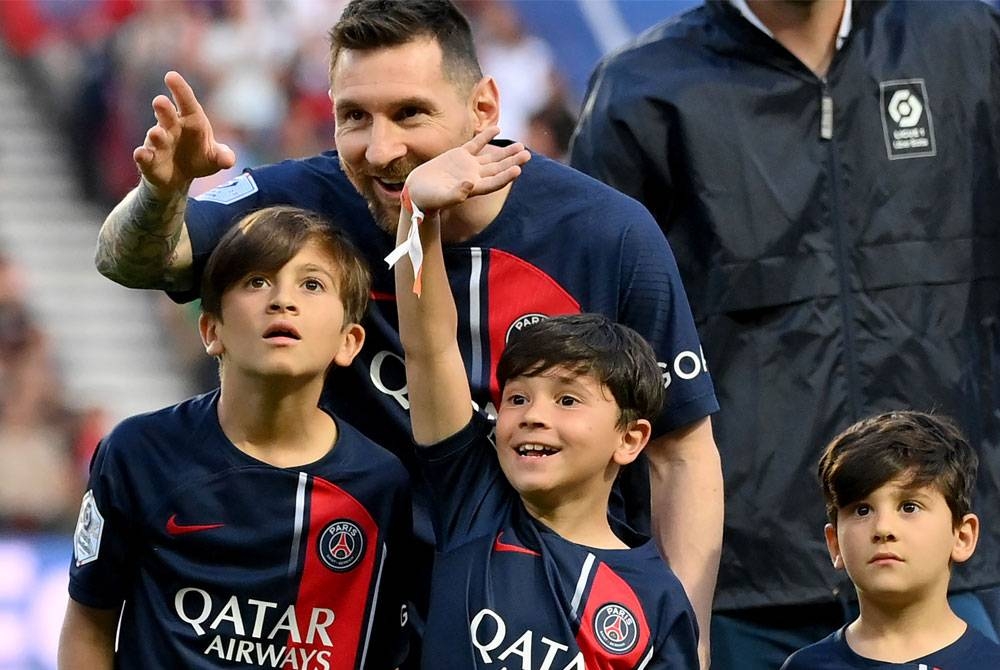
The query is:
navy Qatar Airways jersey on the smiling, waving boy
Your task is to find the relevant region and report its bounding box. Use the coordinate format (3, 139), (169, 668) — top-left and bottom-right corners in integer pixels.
(420, 414), (698, 670)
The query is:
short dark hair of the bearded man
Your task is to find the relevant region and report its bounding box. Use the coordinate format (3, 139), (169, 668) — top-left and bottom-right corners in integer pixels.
(329, 0), (483, 89)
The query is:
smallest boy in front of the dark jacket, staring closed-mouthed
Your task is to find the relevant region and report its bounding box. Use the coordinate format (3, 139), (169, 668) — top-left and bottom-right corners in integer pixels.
(782, 412), (1000, 670)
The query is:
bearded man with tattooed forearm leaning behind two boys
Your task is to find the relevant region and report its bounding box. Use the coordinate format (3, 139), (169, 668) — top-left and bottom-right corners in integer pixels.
(97, 0), (722, 668)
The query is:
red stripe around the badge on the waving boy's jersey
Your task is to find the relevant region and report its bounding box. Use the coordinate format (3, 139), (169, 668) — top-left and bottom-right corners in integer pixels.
(576, 563), (649, 670)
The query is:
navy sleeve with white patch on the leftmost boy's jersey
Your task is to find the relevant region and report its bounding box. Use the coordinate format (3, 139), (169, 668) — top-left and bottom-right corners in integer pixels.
(69, 433), (138, 609)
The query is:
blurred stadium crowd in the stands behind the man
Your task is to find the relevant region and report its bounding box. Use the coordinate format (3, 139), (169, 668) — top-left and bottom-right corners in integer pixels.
(0, 0), (578, 532)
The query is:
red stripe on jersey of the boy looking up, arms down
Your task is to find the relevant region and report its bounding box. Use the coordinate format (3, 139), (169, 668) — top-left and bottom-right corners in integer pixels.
(288, 477), (380, 670)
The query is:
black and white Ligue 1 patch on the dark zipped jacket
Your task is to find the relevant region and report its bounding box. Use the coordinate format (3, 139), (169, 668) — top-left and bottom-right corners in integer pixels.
(879, 79), (937, 160)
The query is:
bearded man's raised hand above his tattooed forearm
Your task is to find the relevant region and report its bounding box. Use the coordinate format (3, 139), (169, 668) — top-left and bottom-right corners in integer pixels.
(132, 71), (236, 194)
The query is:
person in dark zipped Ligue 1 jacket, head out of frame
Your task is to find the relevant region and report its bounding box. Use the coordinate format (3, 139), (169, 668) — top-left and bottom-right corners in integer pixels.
(570, 0), (1000, 670)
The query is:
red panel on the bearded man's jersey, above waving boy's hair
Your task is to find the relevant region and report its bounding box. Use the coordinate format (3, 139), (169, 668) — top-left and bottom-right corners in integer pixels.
(487, 249), (580, 407)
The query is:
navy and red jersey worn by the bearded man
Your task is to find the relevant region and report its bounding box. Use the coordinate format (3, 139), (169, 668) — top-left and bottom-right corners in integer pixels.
(184, 152), (718, 543)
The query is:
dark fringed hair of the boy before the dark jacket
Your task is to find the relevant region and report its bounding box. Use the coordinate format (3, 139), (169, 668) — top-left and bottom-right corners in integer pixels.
(818, 411), (979, 528)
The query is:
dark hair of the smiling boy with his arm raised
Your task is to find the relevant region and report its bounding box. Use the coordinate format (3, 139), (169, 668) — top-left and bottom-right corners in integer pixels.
(497, 314), (665, 428)
